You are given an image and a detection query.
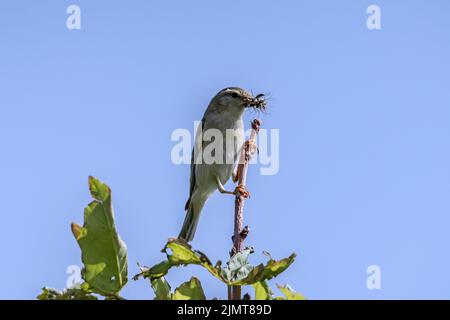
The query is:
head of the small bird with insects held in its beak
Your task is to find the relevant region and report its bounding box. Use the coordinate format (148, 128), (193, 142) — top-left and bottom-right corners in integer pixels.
(210, 87), (266, 114)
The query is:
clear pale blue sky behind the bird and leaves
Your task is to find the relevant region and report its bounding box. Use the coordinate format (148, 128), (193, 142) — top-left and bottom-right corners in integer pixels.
(0, 0), (450, 299)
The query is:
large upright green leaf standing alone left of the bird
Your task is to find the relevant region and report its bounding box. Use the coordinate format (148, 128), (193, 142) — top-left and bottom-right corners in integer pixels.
(72, 177), (128, 296)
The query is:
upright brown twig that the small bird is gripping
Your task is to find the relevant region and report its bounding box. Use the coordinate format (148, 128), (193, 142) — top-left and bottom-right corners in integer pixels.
(228, 119), (261, 300)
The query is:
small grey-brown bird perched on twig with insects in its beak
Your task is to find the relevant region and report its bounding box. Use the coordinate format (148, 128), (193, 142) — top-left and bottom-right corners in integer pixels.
(178, 87), (266, 242)
